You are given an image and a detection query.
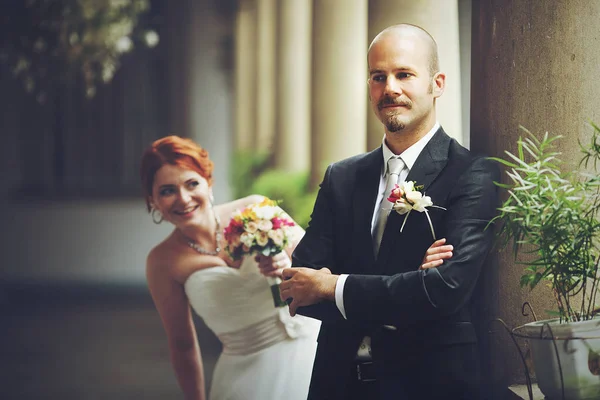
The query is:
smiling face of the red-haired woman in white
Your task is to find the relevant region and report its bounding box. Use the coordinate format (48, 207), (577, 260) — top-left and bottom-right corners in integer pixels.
(150, 164), (212, 227)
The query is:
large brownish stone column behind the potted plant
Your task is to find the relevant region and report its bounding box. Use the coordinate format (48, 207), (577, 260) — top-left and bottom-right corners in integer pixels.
(471, 0), (600, 387)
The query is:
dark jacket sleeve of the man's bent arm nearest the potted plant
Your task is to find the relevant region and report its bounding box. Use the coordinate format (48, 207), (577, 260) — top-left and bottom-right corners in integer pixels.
(344, 158), (499, 325)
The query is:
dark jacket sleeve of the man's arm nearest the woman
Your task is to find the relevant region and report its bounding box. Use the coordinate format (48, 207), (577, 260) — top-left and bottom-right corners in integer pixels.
(292, 165), (343, 321)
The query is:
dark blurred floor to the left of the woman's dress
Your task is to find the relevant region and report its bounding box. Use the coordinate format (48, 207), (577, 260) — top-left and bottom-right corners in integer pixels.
(0, 287), (221, 400)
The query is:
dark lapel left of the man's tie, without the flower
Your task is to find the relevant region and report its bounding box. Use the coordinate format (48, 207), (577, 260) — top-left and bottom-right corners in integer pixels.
(352, 147), (383, 272)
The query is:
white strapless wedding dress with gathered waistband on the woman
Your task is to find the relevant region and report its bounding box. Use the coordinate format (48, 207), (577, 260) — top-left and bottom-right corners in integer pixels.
(184, 257), (321, 400)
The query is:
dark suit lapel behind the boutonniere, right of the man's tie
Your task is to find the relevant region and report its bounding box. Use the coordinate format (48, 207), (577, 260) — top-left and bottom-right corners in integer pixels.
(374, 128), (452, 274)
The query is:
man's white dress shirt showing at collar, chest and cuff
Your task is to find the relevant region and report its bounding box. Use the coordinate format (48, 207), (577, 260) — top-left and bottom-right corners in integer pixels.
(335, 122), (440, 319)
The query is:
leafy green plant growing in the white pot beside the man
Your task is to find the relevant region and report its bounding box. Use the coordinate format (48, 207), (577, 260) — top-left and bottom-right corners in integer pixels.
(493, 124), (600, 322)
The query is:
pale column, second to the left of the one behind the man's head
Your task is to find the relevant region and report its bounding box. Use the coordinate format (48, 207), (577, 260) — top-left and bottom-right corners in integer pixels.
(274, 0), (312, 172)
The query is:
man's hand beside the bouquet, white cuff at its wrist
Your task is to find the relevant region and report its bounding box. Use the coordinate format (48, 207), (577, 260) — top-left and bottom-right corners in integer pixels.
(279, 267), (338, 317)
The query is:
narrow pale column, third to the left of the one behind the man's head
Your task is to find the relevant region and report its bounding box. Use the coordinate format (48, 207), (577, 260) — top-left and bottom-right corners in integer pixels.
(255, 0), (277, 151)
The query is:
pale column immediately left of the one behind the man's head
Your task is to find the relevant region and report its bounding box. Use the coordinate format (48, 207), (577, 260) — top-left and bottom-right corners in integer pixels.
(311, 0), (368, 185)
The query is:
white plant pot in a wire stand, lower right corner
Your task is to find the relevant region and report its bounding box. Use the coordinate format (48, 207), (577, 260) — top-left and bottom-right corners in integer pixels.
(513, 319), (600, 400)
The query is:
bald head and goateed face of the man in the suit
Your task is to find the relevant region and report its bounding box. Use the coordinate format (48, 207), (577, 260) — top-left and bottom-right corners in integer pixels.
(368, 32), (443, 132)
